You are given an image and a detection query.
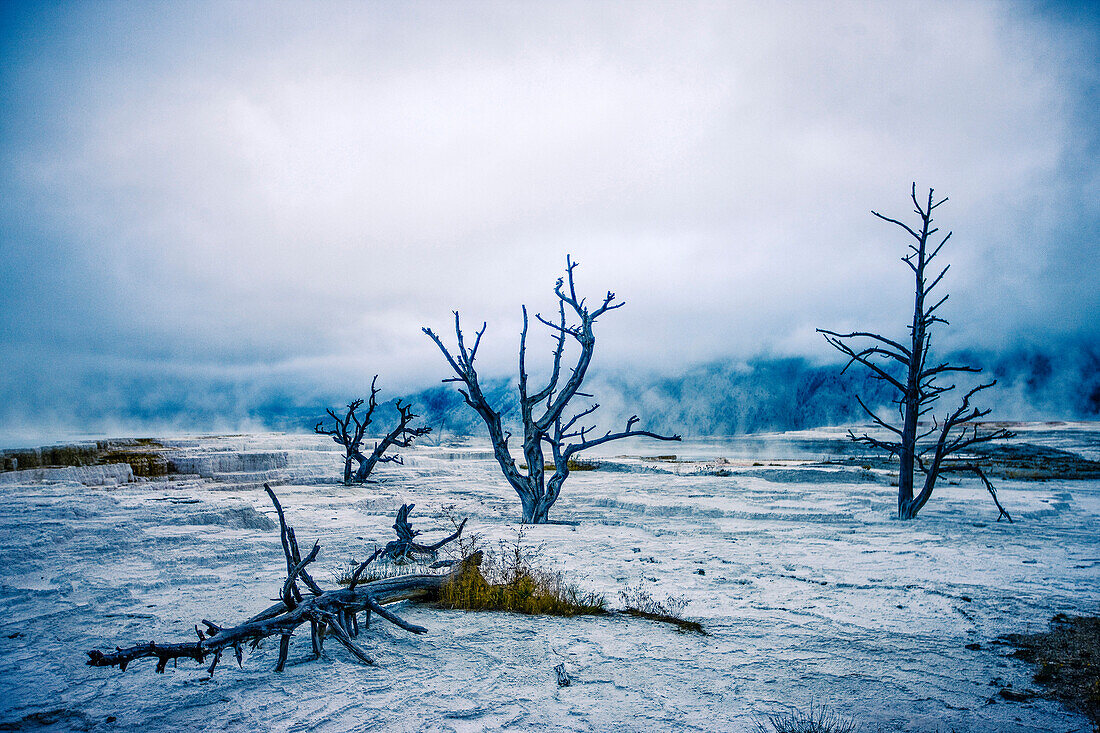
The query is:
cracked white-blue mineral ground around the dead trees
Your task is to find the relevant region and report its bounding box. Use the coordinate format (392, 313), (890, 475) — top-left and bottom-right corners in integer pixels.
(0, 426), (1100, 733)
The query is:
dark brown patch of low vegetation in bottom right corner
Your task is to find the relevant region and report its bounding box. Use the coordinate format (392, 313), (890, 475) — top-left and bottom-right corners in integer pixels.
(1003, 613), (1100, 732)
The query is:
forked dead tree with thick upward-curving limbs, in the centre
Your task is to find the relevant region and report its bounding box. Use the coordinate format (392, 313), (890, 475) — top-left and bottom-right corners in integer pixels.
(424, 256), (680, 524)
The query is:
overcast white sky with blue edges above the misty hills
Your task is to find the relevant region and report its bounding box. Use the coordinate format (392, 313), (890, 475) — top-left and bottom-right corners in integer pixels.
(0, 1), (1100, 431)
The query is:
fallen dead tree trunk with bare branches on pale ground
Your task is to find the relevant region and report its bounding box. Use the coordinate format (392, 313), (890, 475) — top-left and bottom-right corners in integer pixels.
(88, 484), (468, 675)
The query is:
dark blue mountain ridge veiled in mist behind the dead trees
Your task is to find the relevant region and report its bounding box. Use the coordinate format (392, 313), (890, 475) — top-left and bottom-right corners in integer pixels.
(382, 344), (1100, 436)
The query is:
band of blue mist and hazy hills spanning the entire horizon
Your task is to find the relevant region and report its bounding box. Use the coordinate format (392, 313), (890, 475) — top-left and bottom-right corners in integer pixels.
(0, 342), (1100, 446)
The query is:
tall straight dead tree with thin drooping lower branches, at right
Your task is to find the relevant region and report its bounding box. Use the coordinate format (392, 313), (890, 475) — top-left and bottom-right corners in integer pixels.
(817, 184), (1012, 522)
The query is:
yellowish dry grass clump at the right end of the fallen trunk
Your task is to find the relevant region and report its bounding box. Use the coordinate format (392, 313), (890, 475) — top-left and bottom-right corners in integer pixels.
(439, 529), (607, 616)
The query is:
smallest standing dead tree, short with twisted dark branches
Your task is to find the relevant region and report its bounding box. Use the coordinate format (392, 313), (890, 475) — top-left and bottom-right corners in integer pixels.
(314, 374), (431, 484)
